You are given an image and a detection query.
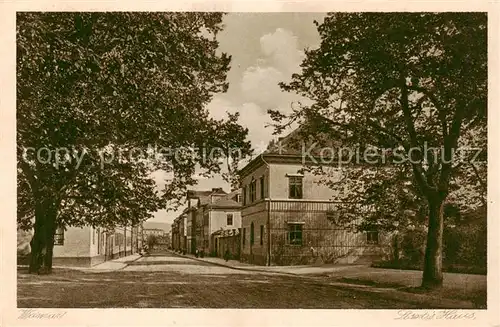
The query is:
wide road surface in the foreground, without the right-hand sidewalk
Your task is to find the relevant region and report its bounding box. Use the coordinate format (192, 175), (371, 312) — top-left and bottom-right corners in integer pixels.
(14, 254), (454, 309)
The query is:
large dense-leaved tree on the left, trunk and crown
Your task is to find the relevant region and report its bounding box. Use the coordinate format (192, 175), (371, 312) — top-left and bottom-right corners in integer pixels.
(17, 12), (250, 273)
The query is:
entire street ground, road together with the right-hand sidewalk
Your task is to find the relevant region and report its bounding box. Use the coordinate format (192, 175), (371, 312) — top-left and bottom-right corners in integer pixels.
(18, 253), (486, 309)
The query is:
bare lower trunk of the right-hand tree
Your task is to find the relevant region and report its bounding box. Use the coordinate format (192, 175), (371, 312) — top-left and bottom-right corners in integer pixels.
(422, 198), (444, 288)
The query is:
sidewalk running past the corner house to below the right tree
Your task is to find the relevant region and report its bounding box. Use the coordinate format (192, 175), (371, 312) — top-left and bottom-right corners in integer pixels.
(174, 253), (487, 308)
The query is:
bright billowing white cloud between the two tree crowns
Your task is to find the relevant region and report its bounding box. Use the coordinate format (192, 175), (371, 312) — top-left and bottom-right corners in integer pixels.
(208, 28), (307, 152)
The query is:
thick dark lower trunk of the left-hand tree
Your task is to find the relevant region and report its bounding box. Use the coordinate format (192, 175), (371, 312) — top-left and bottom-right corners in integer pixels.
(29, 204), (57, 274)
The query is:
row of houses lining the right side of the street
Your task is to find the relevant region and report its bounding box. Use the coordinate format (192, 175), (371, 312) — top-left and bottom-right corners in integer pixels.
(172, 128), (391, 265)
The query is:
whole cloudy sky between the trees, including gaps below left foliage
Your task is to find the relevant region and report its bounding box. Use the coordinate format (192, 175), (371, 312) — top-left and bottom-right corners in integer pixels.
(149, 13), (325, 223)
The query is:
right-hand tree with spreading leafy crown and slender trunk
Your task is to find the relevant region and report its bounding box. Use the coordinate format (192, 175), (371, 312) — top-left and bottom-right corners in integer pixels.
(276, 13), (487, 287)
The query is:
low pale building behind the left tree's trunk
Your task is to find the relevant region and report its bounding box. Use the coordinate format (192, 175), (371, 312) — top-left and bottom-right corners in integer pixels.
(18, 225), (142, 267)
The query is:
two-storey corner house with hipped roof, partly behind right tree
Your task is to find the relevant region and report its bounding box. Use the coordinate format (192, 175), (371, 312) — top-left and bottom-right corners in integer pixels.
(240, 128), (388, 265)
